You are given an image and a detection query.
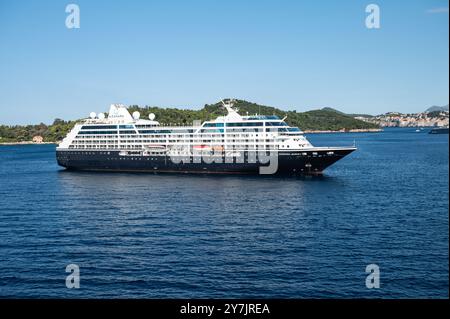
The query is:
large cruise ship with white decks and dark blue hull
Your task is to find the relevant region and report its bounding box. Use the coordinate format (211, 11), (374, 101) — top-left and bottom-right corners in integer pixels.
(56, 100), (356, 175)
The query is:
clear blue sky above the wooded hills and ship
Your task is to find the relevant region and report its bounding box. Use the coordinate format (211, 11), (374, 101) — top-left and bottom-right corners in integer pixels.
(0, 0), (449, 124)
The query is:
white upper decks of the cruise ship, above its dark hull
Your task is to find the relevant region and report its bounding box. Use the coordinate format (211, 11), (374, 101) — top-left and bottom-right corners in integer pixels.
(59, 103), (311, 149)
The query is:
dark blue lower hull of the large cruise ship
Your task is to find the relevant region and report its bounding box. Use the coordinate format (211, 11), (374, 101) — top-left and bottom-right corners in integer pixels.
(56, 147), (355, 175)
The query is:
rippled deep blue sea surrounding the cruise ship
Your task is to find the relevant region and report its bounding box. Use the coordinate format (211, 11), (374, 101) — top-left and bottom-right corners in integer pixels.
(0, 129), (449, 298)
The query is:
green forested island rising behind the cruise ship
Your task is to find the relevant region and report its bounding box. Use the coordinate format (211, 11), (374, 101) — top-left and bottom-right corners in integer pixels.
(0, 100), (379, 143)
